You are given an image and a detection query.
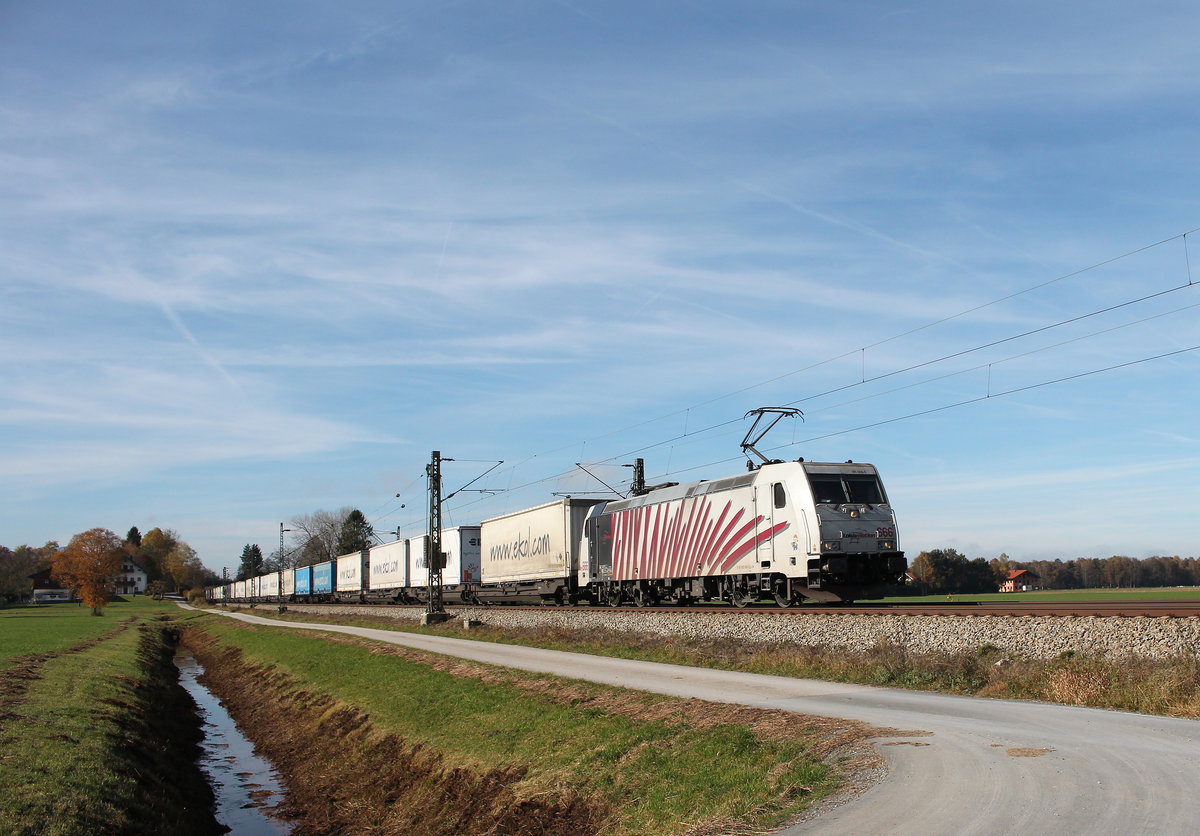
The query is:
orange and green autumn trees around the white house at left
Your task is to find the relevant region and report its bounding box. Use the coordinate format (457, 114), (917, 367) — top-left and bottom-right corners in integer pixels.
(0, 525), (218, 606)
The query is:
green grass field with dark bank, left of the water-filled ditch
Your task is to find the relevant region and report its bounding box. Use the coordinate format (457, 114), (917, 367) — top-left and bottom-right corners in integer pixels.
(0, 597), (218, 836)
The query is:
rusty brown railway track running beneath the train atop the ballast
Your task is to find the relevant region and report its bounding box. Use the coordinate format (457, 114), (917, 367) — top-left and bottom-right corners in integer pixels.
(266, 600), (1200, 618)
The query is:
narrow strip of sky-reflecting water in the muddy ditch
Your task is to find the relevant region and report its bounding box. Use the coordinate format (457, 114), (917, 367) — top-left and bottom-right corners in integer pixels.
(175, 650), (292, 836)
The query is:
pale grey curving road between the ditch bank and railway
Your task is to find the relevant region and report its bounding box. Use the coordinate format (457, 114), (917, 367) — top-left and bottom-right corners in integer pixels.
(199, 613), (1200, 836)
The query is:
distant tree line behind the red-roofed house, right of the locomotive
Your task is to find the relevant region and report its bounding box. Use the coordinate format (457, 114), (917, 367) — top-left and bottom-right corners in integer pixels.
(908, 548), (1200, 595)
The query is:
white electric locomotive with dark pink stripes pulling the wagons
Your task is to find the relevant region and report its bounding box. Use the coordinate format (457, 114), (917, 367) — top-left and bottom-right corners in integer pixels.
(578, 461), (907, 607)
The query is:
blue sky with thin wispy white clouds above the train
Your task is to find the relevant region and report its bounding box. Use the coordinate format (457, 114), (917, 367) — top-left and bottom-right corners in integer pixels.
(0, 0), (1200, 578)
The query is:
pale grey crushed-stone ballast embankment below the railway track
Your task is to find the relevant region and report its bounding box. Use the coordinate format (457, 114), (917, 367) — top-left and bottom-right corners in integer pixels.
(253, 605), (1200, 658)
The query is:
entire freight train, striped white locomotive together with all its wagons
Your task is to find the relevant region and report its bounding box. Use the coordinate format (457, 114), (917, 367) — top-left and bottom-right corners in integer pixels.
(209, 459), (907, 607)
